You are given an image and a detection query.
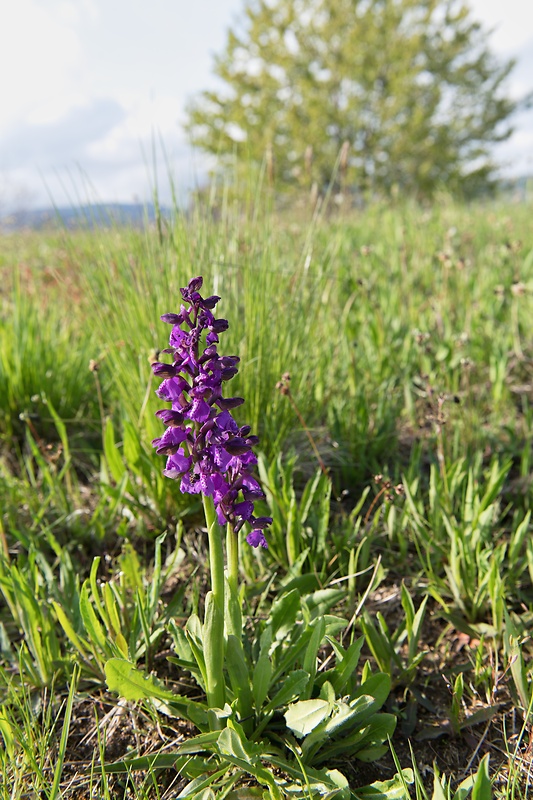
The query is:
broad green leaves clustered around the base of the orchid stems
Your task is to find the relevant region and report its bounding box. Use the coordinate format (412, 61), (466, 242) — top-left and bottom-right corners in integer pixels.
(106, 589), (396, 784)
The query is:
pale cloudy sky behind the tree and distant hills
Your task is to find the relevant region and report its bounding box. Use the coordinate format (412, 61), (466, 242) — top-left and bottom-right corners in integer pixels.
(0, 0), (533, 215)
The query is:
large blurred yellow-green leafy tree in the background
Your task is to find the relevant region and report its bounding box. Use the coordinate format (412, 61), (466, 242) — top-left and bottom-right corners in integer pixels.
(186, 0), (516, 196)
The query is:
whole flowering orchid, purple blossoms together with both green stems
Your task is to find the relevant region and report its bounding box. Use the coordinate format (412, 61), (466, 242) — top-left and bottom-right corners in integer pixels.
(152, 277), (272, 709)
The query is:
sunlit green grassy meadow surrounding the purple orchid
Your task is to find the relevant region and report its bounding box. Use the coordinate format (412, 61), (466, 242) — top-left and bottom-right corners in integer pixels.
(0, 197), (533, 800)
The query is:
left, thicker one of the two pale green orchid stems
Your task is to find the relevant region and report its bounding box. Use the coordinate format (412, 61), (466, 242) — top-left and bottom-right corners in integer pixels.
(203, 495), (225, 708)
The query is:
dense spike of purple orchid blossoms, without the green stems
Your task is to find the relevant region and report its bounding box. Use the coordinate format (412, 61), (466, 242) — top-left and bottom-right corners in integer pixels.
(152, 276), (272, 547)
